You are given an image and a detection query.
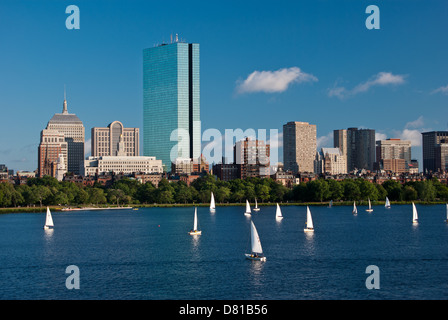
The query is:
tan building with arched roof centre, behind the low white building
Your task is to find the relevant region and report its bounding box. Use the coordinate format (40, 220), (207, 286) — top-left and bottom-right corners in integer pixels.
(91, 121), (140, 157)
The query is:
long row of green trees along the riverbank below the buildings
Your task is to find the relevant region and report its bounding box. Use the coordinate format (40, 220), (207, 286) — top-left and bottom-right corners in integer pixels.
(0, 175), (448, 207)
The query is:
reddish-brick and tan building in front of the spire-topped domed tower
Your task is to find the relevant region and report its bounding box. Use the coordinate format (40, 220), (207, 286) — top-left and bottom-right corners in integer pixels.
(37, 129), (68, 178)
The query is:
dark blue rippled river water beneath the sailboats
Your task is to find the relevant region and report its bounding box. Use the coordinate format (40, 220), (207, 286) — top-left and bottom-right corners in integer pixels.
(0, 205), (448, 300)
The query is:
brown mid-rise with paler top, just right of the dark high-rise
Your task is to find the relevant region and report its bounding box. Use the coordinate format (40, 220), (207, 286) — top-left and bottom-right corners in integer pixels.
(375, 139), (411, 173)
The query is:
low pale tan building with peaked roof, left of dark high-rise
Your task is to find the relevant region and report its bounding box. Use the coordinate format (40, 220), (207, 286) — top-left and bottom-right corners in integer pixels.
(315, 148), (347, 175)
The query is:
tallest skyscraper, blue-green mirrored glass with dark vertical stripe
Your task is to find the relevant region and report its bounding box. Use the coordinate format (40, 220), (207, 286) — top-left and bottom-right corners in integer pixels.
(143, 35), (201, 171)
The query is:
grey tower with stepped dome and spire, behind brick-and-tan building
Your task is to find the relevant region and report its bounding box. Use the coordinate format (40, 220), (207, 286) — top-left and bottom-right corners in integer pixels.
(47, 97), (85, 174)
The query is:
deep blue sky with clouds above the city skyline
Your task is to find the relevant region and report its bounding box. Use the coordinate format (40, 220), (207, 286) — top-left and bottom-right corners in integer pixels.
(0, 0), (448, 170)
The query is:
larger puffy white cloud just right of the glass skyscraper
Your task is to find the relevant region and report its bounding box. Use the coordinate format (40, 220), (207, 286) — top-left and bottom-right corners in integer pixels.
(237, 67), (318, 93)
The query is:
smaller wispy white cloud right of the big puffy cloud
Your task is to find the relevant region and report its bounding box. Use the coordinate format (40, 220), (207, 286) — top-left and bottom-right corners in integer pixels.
(328, 72), (406, 99)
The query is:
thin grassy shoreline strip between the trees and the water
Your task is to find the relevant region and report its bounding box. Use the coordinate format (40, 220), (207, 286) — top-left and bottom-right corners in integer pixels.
(0, 200), (446, 214)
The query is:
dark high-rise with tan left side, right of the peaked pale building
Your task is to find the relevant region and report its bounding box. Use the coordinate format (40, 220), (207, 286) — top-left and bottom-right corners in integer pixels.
(333, 128), (375, 172)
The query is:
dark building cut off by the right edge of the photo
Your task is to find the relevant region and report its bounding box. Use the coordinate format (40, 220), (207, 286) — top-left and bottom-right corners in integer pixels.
(422, 131), (448, 172)
